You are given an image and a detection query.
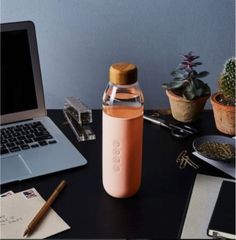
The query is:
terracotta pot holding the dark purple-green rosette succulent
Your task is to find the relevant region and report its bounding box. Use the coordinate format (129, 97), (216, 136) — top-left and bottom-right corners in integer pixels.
(166, 90), (210, 122)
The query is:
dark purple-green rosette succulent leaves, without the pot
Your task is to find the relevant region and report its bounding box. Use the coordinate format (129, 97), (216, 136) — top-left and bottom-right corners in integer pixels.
(162, 52), (210, 100)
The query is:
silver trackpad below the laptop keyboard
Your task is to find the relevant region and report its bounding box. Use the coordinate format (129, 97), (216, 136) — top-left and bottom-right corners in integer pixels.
(1, 155), (31, 183)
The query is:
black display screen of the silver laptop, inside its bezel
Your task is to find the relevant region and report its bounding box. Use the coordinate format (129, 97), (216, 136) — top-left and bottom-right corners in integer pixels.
(0, 29), (38, 115)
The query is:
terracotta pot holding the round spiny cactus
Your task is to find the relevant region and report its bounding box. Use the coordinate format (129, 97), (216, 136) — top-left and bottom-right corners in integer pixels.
(211, 93), (235, 135)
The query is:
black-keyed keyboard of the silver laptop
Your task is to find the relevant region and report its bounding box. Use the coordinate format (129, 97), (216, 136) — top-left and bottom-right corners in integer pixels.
(0, 122), (57, 155)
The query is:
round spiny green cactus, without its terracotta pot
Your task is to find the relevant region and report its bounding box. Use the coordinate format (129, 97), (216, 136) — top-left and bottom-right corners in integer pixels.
(218, 57), (236, 105)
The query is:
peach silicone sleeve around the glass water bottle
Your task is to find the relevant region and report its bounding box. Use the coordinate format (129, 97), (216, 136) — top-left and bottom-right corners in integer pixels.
(102, 112), (143, 198)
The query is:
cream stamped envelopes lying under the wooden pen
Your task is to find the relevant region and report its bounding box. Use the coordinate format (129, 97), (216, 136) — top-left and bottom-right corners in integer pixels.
(0, 188), (70, 239)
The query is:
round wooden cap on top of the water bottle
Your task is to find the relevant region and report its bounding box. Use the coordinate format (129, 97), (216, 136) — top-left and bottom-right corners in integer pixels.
(109, 62), (138, 85)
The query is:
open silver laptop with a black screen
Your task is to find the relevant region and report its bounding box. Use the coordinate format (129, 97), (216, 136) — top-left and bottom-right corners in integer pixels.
(0, 21), (87, 184)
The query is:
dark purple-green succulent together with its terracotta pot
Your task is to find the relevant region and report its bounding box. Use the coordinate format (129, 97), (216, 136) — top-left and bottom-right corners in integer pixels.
(162, 52), (210, 122)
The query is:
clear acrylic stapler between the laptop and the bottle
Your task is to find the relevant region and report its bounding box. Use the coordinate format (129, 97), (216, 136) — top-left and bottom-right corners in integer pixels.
(63, 97), (96, 141)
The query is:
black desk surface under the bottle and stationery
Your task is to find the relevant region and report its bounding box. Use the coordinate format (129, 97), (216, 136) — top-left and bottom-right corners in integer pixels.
(1, 110), (232, 239)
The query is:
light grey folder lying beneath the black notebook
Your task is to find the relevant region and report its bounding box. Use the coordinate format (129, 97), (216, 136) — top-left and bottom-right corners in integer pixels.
(180, 174), (234, 239)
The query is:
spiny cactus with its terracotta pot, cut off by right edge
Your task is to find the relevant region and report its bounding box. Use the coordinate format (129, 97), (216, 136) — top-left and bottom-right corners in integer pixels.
(211, 57), (236, 135)
